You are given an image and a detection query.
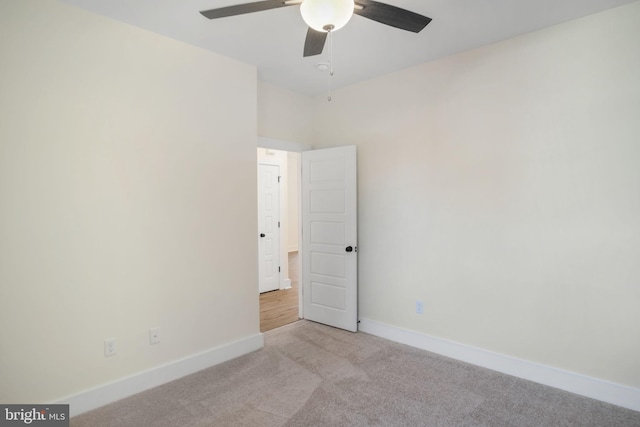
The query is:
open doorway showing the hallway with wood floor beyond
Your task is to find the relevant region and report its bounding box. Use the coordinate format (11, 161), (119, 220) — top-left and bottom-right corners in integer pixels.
(257, 148), (302, 332)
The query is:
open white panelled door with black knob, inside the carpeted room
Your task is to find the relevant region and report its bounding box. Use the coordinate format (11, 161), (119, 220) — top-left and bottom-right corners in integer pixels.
(302, 146), (358, 332)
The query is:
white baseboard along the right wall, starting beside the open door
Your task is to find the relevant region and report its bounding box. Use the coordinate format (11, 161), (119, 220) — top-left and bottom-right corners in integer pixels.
(359, 319), (640, 411)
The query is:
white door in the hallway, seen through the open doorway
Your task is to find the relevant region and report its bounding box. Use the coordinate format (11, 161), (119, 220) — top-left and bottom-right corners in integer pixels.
(258, 165), (280, 293)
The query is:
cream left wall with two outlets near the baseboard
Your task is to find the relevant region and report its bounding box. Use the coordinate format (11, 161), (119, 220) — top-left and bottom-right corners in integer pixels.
(0, 0), (259, 403)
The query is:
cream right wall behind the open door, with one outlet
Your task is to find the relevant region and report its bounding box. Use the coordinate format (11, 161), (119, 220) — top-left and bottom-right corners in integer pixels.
(313, 2), (640, 388)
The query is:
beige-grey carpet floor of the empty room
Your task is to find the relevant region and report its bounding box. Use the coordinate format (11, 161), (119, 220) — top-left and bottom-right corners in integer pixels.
(71, 321), (640, 427)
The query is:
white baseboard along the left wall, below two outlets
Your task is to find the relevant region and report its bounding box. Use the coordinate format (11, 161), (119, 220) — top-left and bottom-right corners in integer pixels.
(53, 334), (264, 417)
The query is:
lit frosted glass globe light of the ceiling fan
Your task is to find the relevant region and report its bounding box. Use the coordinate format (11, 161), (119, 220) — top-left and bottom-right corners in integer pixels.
(300, 0), (355, 33)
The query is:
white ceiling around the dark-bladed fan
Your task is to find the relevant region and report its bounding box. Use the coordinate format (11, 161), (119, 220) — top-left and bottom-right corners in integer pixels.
(62, 0), (636, 95)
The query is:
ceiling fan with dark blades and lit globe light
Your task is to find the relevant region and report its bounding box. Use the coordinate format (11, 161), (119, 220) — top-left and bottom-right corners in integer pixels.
(200, 0), (431, 57)
